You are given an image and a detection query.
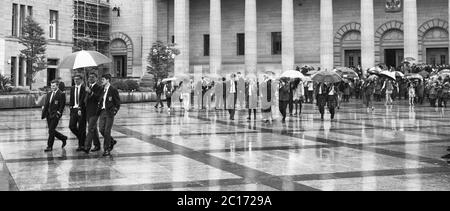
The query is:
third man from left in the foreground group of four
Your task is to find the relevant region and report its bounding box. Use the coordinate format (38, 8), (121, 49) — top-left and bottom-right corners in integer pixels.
(84, 73), (103, 154)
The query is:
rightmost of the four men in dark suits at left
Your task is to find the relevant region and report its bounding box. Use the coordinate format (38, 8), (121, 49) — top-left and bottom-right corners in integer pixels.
(97, 74), (120, 156)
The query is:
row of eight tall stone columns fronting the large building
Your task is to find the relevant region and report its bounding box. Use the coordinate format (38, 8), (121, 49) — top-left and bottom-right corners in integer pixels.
(144, 0), (436, 77)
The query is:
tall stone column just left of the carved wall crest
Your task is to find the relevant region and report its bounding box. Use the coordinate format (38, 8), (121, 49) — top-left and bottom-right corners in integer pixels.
(361, 0), (375, 75)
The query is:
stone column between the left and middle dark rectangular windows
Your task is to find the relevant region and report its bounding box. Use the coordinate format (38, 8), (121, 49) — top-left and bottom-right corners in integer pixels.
(209, 0), (222, 74)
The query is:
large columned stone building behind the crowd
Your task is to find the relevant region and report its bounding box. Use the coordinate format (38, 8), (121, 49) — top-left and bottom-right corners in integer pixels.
(111, 0), (450, 77)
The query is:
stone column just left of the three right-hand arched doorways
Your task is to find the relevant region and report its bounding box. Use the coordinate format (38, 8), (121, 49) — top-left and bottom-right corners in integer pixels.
(320, 0), (334, 70)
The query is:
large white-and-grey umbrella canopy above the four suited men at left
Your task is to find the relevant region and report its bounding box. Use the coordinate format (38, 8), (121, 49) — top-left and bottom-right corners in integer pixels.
(58, 51), (111, 69)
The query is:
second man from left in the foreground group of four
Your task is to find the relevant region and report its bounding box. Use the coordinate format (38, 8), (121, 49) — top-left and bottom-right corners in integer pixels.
(69, 75), (86, 152)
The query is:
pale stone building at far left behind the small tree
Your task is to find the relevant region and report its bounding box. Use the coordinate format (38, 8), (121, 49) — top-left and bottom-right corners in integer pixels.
(0, 0), (73, 88)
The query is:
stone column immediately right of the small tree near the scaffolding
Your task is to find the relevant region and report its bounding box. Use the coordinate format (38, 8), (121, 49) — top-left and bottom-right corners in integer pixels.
(174, 0), (189, 75)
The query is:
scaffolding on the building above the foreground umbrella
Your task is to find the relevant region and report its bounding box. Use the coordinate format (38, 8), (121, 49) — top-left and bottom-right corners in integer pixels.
(73, 0), (111, 55)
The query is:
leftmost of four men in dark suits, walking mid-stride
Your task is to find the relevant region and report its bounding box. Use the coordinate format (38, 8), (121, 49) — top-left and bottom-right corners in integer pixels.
(42, 80), (67, 152)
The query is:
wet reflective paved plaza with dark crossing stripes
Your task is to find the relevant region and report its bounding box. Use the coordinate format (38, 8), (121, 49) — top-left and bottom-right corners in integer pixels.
(0, 102), (450, 191)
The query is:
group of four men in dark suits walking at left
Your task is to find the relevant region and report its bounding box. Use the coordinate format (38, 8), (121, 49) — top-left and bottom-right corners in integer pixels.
(42, 73), (120, 156)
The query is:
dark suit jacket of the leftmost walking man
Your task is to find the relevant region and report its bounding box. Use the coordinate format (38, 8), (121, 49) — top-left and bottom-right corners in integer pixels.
(42, 90), (66, 119)
